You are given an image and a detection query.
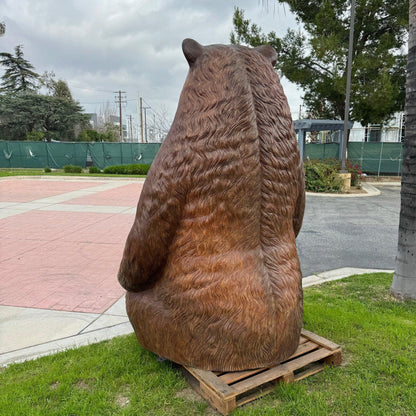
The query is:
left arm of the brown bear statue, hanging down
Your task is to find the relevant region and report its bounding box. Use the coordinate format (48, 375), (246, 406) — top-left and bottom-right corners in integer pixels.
(118, 156), (184, 291)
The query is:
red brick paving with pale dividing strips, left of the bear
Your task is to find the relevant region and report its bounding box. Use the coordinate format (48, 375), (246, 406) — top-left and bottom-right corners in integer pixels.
(0, 178), (142, 313)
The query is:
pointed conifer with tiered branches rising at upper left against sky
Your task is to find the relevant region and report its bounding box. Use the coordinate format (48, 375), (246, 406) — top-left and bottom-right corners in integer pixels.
(0, 45), (39, 94)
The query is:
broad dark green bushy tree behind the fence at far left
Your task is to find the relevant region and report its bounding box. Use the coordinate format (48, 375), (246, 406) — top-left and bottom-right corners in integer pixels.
(0, 94), (88, 140)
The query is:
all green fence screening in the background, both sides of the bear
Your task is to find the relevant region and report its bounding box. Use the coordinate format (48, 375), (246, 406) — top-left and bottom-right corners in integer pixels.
(0, 141), (402, 175)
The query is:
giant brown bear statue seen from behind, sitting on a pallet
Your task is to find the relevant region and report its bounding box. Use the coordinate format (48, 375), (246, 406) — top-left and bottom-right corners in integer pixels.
(118, 39), (305, 371)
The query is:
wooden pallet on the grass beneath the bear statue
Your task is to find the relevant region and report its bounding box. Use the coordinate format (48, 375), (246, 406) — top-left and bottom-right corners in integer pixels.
(181, 329), (342, 415)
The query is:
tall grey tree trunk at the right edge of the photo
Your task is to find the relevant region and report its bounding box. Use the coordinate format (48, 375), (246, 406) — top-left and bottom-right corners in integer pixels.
(390, 0), (416, 300)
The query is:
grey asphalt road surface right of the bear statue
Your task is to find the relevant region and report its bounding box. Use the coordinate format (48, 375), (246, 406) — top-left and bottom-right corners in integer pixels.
(297, 185), (400, 277)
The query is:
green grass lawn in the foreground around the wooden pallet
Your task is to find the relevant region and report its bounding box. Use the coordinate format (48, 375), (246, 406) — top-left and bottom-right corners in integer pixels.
(0, 273), (416, 416)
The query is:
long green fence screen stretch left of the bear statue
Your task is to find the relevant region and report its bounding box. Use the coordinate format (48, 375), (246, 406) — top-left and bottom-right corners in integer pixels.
(0, 141), (161, 169)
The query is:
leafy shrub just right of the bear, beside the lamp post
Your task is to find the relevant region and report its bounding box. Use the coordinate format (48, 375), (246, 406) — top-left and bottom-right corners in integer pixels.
(304, 160), (342, 192)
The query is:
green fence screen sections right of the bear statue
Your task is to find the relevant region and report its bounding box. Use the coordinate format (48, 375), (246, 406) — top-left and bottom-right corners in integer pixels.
(305, 142), (403, 175)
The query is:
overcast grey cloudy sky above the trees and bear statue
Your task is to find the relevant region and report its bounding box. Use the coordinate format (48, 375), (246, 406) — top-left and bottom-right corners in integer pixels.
(0, 0), (301, 132)
